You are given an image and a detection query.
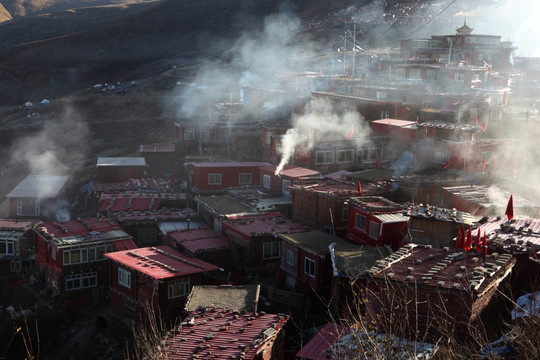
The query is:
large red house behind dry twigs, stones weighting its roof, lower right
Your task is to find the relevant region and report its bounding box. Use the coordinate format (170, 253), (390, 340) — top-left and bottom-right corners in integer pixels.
(366, 244), (515, 341)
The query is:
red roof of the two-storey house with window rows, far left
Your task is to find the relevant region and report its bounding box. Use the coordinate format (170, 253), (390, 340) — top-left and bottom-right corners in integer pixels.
(40, 218), (120, 238)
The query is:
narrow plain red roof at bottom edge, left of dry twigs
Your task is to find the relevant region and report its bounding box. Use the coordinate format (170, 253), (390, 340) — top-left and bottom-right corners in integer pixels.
(296, 323), (350, 360)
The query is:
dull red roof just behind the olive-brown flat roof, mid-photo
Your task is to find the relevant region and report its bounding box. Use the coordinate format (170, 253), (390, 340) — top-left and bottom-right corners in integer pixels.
(223, 212), (312, 238)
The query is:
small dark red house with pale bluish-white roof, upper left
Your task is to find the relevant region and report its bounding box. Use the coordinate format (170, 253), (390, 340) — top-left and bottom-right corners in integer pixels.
(96, 157), (146, 183)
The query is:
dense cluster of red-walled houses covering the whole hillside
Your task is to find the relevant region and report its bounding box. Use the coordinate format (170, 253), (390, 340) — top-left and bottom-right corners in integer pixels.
(0, 21), (540, 359)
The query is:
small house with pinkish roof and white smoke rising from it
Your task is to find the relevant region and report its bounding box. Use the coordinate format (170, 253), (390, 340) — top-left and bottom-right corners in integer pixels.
(260, 165), (322, 195)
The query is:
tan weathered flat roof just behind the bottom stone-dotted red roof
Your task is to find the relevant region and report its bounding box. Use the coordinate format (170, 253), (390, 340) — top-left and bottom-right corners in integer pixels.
(184, 284), (260, 311)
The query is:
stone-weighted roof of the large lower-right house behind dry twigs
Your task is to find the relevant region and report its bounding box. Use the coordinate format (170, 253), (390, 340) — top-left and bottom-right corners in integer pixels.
(366, 244), (515, 294)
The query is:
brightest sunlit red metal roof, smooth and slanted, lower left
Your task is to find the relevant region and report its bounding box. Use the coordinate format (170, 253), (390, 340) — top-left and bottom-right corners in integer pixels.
(105, 246), (219, 279)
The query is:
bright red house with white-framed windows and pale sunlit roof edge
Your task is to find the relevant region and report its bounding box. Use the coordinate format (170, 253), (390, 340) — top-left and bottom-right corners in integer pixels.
(346, 196), (409, 250)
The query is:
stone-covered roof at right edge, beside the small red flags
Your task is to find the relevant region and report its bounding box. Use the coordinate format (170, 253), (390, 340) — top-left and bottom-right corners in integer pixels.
(473, 216), (540, 253)
